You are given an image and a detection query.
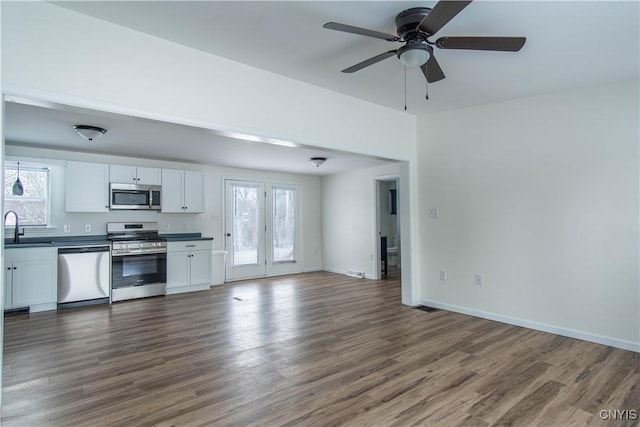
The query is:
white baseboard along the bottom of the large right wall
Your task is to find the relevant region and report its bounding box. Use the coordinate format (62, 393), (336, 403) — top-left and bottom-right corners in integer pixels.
(420, 299), (640, 353)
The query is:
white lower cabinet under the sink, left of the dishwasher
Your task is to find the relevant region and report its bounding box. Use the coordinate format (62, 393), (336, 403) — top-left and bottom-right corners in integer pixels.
(4, 248), (58, 312)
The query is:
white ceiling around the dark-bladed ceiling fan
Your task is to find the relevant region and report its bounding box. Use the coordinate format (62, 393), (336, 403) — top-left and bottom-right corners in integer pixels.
(54, 0), (640, 114)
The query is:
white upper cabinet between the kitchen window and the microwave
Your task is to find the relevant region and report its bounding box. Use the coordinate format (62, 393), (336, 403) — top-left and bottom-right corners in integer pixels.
(65, 162), (109, 212)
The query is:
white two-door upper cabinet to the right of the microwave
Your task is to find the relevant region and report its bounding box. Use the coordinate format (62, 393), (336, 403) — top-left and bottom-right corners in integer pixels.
(161, 169), (204, 213)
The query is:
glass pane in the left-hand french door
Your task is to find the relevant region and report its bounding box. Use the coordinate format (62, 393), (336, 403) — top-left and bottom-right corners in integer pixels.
(232, 185), (259, 266)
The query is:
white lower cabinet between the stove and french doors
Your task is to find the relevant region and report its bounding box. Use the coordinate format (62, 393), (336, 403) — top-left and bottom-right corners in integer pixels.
(167, 240), (211, 295)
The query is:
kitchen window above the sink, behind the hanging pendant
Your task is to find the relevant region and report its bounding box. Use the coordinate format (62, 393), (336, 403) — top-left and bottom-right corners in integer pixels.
(4, 163), (49, 226)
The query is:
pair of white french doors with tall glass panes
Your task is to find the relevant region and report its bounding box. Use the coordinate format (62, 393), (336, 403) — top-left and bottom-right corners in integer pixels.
(225, 180), (301, 280)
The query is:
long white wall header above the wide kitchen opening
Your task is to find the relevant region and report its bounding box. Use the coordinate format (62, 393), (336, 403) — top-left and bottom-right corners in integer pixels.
(0, 1), (416, 160)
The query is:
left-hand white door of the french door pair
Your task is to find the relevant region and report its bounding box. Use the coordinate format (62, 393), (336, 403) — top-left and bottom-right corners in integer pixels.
(225, 180), (266, 280)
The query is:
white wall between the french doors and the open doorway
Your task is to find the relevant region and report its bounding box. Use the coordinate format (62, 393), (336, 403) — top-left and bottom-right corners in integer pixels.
(322, 164), (400, 278)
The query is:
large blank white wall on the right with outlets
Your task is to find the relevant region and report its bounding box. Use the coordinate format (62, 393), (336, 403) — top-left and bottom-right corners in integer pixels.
(418, 81), (640, 351)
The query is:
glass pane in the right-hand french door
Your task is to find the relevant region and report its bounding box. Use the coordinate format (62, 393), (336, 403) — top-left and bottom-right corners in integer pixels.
(273, 187), (296, 262)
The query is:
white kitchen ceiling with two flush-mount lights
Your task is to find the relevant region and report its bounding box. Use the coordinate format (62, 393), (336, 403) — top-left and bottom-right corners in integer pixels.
(4, 97), (388, 175)
